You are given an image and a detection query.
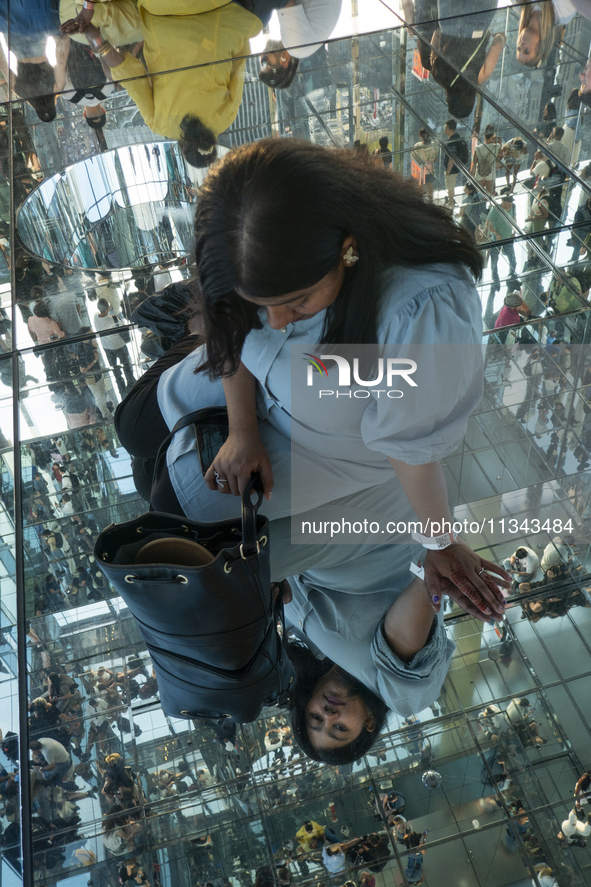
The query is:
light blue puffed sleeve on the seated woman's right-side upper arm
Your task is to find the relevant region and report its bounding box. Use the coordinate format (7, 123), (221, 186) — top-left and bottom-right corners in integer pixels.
(361, 266), (484, 465)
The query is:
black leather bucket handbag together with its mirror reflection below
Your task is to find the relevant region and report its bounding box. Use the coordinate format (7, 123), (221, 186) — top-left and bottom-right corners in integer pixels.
(94, 475), (295, 723)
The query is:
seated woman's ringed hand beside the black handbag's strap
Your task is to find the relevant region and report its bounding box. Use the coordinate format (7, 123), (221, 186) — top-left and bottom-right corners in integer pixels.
(205, 427), (274, 501)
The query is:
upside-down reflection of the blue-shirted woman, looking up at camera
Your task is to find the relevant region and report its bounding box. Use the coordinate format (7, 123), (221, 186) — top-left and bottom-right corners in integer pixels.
(286, 579), (434, 765)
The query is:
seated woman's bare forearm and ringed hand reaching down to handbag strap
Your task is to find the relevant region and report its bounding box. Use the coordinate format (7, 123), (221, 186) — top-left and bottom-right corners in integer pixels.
(205, 362), (273, 500)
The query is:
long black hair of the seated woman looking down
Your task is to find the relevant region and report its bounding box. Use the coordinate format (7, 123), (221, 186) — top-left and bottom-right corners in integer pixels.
(195, 139), (482, 377)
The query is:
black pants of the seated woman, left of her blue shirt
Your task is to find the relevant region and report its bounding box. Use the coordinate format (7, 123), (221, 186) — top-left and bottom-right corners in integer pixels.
(115, 336), (202, 516)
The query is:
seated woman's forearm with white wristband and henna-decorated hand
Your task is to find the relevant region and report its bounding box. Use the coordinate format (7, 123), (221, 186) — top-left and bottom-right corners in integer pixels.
(389, 457), (510, 622)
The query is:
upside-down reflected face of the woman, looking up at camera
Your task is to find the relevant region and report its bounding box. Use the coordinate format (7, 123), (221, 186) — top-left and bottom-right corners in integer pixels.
(305, 667), (375, 749)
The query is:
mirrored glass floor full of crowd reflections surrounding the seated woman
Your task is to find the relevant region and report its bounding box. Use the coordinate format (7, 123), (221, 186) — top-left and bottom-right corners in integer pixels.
(0, 0), (591, 887)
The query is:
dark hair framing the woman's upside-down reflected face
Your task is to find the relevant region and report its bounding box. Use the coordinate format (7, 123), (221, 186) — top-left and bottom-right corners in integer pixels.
(288, 641), (388, 766)
